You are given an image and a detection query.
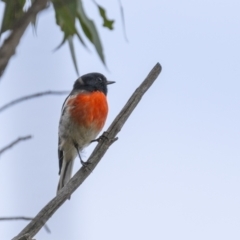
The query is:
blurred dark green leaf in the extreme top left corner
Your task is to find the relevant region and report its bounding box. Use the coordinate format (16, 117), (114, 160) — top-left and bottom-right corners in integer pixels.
(0, 0), (26, 35)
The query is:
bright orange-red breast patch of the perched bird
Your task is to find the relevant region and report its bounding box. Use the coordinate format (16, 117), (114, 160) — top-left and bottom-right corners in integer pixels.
(68, 91), (108, 131)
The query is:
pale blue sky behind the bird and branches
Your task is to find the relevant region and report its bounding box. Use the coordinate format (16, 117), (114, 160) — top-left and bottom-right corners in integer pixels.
(0, 0), (240, 240)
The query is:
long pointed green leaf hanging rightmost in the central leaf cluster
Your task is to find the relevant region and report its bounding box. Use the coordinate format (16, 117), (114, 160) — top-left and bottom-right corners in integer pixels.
(77, 0), (105, 64)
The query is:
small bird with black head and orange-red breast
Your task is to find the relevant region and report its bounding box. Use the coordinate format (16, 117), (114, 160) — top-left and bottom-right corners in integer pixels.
(57, 73), (115, 193)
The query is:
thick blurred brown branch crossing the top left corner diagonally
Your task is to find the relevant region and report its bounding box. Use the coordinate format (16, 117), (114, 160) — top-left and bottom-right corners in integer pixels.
(0, 0), (48, 77)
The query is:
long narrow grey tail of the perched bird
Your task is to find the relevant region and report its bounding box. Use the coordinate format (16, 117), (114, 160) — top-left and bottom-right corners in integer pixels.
(57, 160), (74, 194)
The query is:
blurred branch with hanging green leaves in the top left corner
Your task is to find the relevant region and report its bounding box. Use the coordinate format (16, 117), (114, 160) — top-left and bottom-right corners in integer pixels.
(0, 0), (116, 77)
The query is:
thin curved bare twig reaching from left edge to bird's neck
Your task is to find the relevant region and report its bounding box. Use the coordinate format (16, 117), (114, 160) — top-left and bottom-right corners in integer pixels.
(0, 91), (69, 112)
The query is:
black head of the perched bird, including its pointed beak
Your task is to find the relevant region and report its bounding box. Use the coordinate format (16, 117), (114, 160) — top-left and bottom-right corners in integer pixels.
(73, 73), (115, 95)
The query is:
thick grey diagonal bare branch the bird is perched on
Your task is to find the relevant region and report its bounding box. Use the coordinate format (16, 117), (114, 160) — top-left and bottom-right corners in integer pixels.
(13, 63), (162, 240)
